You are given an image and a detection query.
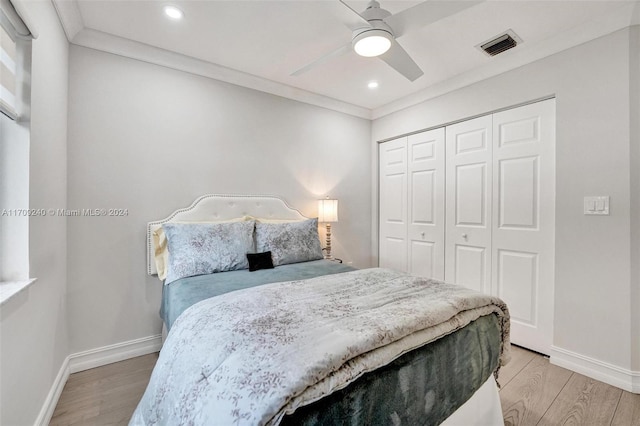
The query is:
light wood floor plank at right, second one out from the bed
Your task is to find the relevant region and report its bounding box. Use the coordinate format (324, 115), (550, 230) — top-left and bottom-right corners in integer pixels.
(540, 374), (622, 426)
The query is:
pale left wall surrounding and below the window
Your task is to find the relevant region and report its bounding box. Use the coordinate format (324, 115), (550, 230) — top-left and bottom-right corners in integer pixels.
(0, 0), (69, 425)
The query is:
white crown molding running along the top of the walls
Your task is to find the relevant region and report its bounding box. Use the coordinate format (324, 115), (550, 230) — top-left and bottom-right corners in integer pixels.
(52, 0), (640, 120)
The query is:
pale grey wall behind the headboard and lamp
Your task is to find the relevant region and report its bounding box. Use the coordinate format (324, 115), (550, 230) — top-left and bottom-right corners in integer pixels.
(68, 46), (371, 352)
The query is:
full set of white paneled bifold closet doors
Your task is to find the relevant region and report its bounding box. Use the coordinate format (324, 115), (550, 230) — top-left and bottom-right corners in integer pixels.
(379, 99), (555, 354)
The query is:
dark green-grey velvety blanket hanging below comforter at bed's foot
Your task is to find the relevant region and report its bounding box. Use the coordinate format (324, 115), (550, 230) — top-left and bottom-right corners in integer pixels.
(281, 314), (501, 426)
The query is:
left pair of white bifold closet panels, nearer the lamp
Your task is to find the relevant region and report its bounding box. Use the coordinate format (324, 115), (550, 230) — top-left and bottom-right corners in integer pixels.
(379, 128), (445, 280)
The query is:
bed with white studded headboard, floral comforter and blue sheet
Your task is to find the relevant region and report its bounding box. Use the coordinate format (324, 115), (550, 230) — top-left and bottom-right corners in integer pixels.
(135, 195), (509, 425)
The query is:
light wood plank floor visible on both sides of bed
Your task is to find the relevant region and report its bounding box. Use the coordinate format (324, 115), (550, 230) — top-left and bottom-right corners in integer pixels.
(50, 346), (640, 426)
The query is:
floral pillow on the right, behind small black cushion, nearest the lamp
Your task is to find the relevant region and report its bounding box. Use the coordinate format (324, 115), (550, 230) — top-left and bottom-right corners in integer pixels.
(256, 219), (323, 266)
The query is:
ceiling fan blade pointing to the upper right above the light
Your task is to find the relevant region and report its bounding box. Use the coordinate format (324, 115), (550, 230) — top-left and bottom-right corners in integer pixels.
(384, 0), (482, 37)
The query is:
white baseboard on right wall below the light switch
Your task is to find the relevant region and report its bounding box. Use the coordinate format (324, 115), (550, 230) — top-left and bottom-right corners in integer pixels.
(549, 346), (640, 393)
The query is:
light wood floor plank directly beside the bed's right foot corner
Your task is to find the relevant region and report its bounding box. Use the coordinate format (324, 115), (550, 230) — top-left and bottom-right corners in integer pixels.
(500, 355), (573, 426)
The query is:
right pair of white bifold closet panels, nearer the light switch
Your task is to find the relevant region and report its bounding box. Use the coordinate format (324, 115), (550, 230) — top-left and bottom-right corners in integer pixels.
(445, 100), (555, 354)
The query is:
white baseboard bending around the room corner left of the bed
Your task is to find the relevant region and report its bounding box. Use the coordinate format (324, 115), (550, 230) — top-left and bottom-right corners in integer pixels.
(35, 334), (162, 426)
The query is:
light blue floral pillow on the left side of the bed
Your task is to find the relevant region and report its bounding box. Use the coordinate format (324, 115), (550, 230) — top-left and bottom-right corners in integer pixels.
(162, 220), (255, 284)
